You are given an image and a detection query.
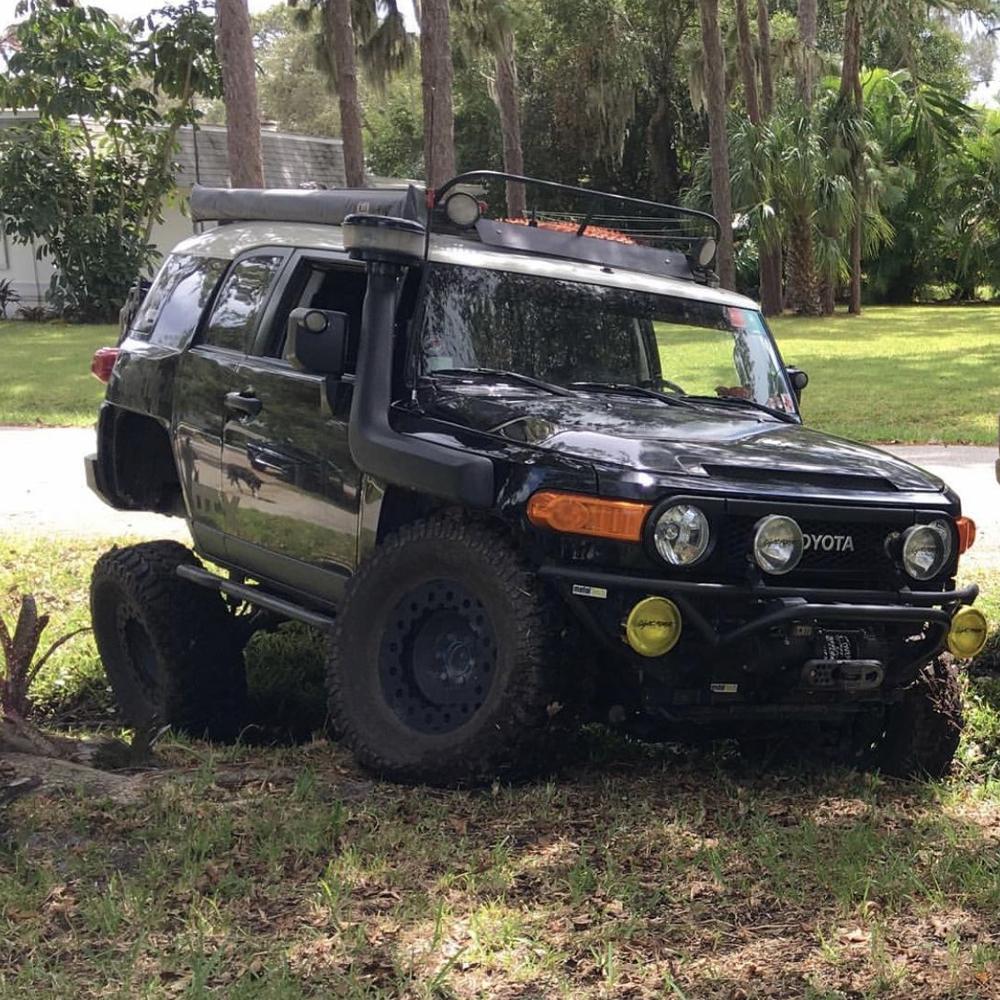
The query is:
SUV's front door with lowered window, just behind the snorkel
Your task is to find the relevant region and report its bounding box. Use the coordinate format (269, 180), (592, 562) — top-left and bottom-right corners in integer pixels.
(222, 254), (365, 601)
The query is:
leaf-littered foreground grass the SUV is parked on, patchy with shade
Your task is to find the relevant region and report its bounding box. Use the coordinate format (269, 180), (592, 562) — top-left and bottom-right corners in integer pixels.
(0, 537), (1000, 1000)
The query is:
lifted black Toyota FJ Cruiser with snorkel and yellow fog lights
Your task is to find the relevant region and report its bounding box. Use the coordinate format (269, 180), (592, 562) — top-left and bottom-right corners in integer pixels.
(87, 172), (986, 782)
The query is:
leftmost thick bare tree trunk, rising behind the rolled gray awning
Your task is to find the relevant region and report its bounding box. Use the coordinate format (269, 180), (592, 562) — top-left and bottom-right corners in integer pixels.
(215, 0), (264, 188)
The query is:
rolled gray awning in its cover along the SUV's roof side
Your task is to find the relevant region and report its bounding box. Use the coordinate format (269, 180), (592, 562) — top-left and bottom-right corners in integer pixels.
(191, 184), (427, 226)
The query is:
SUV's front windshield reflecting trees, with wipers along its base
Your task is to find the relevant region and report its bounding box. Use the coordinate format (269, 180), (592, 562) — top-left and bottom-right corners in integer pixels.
(418, 264), (796, 413)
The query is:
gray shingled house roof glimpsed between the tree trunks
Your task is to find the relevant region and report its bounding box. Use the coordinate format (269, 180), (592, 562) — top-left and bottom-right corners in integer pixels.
(0, 111), (346, 188)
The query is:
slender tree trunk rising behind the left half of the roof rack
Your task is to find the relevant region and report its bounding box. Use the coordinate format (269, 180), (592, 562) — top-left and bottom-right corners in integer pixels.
(456, 0), (526, 218)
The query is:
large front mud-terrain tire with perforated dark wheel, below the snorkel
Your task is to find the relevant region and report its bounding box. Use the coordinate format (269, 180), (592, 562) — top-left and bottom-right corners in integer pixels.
(327, 517), (562, 785)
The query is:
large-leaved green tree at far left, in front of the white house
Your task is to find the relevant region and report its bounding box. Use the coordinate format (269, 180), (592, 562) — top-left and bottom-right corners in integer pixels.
(0, 0), (219, 320)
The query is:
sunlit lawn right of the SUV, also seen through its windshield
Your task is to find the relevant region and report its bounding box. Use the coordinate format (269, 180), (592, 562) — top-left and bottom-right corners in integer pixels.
(660, 306), (1000, 444)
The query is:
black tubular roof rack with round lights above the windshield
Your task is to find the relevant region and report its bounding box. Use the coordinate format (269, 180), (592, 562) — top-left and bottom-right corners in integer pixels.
(428, 170), (721, 284)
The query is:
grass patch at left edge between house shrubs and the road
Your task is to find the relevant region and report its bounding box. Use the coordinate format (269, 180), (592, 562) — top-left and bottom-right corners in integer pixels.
(0, 321), (118, 427)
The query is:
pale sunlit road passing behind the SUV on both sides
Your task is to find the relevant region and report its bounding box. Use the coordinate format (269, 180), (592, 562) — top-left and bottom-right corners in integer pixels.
(0, 428), (1000, 563)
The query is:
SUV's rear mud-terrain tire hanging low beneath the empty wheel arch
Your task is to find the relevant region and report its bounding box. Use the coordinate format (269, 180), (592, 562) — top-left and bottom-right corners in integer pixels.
(90, 541), (246, 740)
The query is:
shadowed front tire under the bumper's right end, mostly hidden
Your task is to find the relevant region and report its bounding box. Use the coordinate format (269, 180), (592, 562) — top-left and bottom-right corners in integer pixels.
(865, 657), (964, 778)
